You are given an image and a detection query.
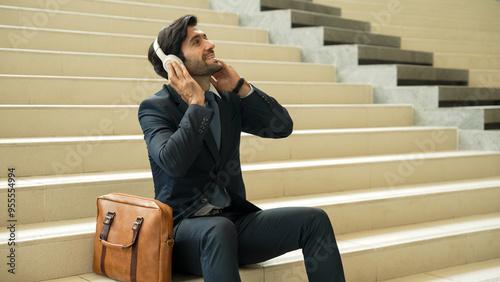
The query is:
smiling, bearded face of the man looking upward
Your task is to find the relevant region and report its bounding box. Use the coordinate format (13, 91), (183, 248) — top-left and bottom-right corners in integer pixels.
(181, 26), (222, 76)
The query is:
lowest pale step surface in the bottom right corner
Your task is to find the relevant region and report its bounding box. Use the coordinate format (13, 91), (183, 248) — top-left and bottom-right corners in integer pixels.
(383, 258), (500, 282)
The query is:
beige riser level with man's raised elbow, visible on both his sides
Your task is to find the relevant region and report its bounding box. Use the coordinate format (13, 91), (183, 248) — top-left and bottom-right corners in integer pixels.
(0, 106), (412, 138)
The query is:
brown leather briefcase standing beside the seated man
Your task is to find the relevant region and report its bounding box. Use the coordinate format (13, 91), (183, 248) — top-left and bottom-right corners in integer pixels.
(93, 194), (174, 282)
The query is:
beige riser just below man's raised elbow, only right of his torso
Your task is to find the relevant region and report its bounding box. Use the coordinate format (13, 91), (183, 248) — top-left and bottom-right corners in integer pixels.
(240, 129), (457, 163)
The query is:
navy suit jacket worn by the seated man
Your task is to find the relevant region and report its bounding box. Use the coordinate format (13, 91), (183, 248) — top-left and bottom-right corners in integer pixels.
(139, 85), (293, 224)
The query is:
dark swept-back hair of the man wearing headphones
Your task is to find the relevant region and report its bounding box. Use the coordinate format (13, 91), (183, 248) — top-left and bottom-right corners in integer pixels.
(148, 15), (198, 79)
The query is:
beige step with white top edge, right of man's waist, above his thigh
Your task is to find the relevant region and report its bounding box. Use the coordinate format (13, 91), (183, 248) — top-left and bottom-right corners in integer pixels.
(242, 151), (500, 199)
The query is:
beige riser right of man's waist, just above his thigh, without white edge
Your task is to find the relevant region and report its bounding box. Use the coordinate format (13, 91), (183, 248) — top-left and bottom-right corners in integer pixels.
(243, 155), (500, 199)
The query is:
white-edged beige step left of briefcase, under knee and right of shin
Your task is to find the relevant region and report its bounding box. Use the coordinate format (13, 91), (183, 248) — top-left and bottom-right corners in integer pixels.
(1, 213), (500, 281)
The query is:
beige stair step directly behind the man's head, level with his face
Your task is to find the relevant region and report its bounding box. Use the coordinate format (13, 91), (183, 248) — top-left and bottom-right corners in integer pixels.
(0, 26), (300, 62)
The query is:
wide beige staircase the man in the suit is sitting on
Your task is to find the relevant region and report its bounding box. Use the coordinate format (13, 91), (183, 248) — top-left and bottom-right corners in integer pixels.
(0, 0), (500, 281)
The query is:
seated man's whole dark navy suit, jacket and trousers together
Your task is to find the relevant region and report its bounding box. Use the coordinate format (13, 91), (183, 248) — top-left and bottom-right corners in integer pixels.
(139, 85), (344, 282)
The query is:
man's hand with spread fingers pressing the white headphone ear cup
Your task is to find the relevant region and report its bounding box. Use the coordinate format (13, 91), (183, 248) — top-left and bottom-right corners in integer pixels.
(167, 62), (205, 106)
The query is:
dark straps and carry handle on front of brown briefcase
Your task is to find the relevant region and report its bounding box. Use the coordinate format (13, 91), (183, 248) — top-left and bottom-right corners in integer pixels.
(99, 211), (144, 281)
